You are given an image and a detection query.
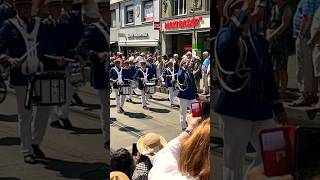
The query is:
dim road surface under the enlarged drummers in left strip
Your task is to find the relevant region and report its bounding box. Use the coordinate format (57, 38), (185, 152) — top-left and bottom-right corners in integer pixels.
(0, 90), (108, 180)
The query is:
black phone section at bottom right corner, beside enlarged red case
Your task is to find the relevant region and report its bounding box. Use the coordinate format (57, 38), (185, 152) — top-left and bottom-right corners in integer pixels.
(295, 127), (320, 180)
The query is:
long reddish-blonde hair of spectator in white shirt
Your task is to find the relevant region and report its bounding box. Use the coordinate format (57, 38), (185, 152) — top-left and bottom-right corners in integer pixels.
(178, 118), (210, 180)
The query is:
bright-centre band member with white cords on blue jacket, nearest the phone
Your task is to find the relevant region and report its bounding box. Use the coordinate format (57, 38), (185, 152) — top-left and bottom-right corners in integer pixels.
(178, 58), (198, 131)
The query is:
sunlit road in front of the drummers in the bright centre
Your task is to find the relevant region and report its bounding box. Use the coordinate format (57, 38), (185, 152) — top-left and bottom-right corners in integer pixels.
(110, 90), (181, 151)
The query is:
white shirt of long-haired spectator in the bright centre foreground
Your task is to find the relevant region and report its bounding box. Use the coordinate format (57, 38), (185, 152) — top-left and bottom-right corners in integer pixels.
(148, 138), (199, 180)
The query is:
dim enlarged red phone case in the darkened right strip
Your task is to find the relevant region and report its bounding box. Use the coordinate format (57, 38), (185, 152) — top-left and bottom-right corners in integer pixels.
(260, 126), (296, 177)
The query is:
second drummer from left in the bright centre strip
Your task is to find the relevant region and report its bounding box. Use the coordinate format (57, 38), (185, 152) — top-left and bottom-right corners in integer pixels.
(136, 56), (156, 110)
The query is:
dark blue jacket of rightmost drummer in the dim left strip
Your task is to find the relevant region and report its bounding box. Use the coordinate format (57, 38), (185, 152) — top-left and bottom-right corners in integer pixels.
(76, 21), (109, 89)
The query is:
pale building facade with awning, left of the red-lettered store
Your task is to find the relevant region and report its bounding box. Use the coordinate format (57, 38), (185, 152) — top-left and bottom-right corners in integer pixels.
(110, 0), (160, 55)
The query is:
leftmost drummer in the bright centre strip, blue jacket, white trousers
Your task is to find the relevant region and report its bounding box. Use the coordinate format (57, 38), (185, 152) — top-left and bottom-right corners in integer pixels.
(110, 58), (126, 113)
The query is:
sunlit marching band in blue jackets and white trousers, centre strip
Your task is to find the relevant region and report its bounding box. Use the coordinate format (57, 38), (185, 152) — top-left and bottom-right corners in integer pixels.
(109, 52), (207, 130)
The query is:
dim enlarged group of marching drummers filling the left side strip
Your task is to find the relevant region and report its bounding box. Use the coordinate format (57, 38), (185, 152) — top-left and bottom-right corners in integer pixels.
(0, 0), (110, 164)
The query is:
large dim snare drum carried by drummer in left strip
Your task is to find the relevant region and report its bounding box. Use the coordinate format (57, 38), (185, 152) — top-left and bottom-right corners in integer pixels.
(25, 72), (66, 108)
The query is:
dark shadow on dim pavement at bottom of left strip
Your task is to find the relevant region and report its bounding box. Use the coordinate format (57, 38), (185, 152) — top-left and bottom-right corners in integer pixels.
(39, 158), (109, 180)
